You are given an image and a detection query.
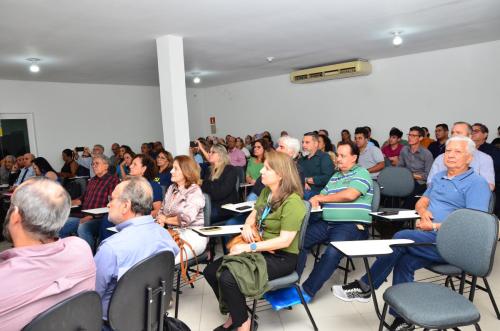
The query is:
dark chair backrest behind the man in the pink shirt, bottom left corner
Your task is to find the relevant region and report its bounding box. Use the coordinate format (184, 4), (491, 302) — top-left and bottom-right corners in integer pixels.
(23, 291), (102, 331)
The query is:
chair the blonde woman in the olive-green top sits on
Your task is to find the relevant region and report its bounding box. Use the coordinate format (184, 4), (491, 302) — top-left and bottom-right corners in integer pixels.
(250, 201), (318, 331)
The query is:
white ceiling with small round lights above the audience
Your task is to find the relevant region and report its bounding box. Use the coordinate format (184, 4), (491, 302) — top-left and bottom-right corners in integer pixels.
(0, 0), (500, 87)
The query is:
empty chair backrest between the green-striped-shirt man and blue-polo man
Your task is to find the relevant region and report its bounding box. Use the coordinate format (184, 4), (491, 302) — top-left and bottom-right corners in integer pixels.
(377, 167), (415, 198)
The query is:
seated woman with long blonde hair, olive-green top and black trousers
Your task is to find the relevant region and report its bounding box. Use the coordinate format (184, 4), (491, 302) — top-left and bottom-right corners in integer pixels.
(203, 152), (306, 331)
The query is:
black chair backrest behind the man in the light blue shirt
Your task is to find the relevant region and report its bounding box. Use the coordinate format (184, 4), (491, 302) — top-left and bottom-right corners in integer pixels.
(108, 251), (175, 331)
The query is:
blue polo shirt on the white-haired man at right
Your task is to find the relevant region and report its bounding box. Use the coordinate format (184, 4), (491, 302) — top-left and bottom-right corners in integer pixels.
(424, 168), (491, 223)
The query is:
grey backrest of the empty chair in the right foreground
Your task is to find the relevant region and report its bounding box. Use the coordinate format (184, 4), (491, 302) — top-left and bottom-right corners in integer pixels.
(437, 209), (498, 277)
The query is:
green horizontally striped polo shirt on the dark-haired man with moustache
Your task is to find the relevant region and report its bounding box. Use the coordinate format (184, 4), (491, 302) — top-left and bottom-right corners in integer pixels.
(320, 165), (373, 223)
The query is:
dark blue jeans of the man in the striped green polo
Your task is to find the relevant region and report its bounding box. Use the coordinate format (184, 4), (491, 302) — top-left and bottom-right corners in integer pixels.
(297, 220), (368, 297)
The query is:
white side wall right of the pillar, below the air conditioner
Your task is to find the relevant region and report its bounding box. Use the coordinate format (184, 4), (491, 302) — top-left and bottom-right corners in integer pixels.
(188, 41), (500, 142)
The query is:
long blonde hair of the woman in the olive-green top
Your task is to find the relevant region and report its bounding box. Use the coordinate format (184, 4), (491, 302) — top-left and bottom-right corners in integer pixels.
(266, 151), (304, 209)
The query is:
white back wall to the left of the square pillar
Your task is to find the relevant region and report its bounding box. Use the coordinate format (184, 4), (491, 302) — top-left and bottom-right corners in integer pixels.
(0, 80), (163, 170)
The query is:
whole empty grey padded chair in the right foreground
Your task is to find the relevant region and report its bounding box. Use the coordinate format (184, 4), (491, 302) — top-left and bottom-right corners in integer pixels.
(379, 209), (498, 330)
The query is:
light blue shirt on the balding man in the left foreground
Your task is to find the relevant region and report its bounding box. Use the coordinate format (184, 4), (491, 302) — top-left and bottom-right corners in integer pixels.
(94, 216), (179, 320)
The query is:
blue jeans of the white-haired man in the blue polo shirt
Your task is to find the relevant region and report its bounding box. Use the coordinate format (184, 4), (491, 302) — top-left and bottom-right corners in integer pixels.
(361, 230), (446, 289)
